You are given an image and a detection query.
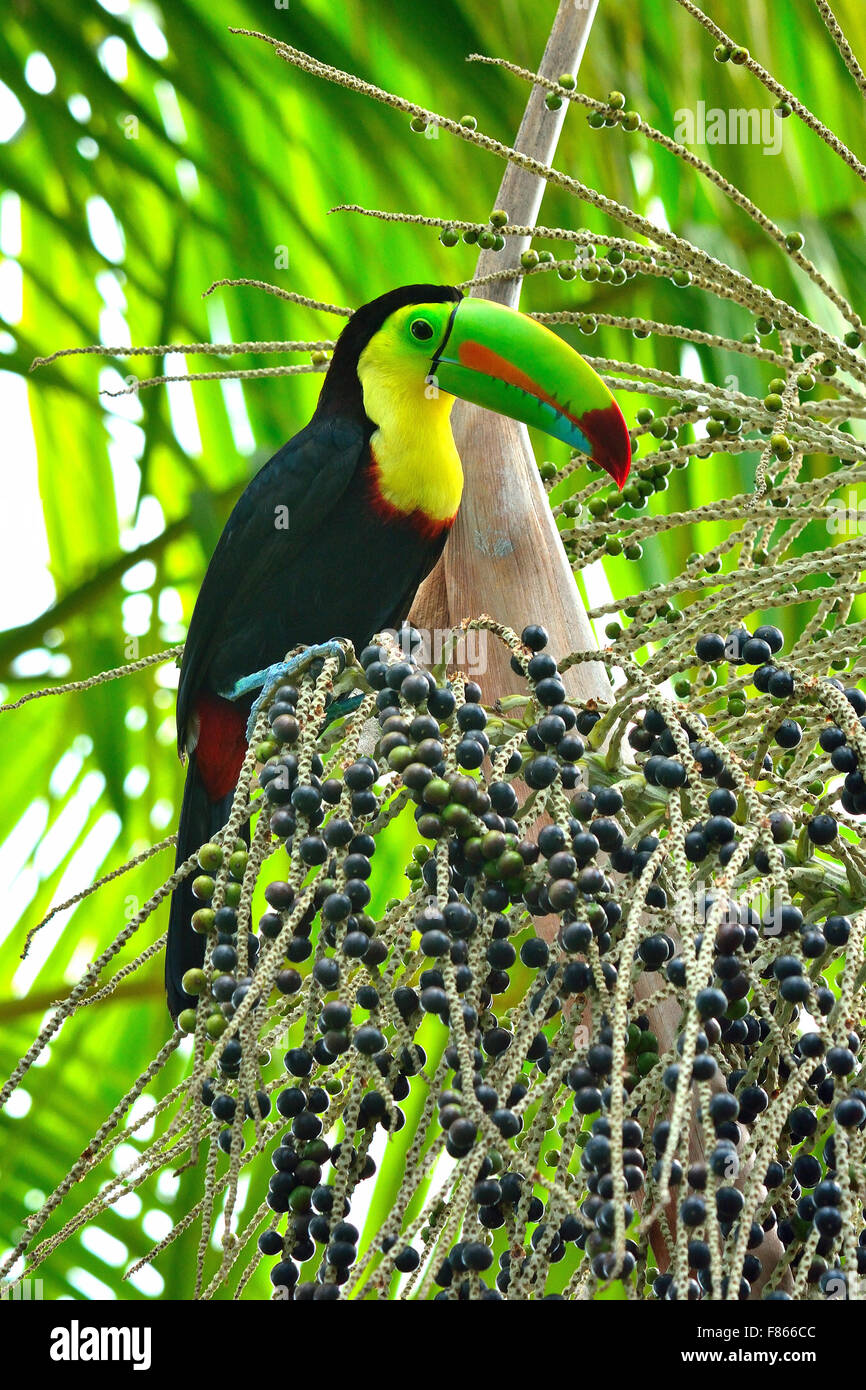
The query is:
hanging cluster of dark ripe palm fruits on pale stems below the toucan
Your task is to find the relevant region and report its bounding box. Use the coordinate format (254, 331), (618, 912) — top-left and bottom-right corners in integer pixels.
(157, 614), (866, 1301)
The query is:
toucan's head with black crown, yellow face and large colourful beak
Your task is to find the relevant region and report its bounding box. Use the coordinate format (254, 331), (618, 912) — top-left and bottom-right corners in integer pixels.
(318, 285), (631, 487)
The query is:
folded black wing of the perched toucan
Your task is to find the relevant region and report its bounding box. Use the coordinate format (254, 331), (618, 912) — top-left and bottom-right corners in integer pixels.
(178, 417), (368, 751)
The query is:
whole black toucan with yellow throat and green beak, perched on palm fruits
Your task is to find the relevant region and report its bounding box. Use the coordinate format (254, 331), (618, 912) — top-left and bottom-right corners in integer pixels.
(165, 285), (631, 1019)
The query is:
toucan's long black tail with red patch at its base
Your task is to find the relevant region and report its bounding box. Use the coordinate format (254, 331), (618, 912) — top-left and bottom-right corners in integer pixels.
(165, 696), (249, 1019)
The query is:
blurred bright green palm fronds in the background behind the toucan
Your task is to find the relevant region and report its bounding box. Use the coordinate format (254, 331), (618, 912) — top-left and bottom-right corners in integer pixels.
(0, 0), (866, 1297)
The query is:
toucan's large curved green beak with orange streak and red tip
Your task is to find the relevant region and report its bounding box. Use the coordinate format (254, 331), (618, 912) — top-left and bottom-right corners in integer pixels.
(430, 299), (631, 488)
